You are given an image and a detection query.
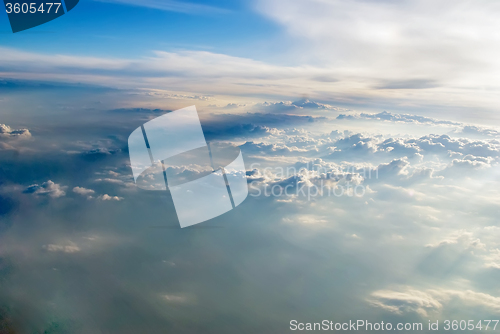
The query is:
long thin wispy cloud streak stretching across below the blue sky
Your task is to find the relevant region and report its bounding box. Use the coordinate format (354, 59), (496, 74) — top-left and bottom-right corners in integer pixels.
(0, 48), (500, 117)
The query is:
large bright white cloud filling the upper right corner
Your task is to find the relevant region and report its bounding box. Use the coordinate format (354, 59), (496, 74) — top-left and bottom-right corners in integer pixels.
(256, 0), (500, 116)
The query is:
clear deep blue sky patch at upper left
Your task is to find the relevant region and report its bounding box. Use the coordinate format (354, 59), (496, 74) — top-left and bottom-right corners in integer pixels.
(0, 0), (279, 58)
